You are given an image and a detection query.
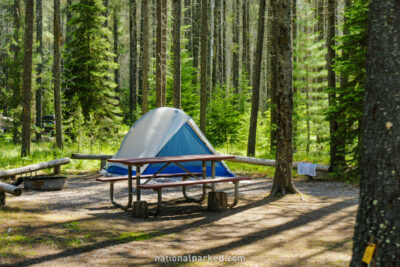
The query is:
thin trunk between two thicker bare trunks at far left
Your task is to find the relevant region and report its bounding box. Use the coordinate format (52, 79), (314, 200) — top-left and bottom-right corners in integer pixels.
(36, 0), (43, 142)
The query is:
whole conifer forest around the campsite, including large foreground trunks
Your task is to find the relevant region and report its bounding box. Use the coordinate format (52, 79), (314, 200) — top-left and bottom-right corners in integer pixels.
(0, 0), (400, 266)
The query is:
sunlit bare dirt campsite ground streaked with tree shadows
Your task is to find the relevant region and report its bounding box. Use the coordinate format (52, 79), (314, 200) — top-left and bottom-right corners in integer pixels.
(0, 173), (358, 267)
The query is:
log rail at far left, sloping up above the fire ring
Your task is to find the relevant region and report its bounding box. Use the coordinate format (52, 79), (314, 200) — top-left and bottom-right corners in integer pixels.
(0, 158), (70, 178)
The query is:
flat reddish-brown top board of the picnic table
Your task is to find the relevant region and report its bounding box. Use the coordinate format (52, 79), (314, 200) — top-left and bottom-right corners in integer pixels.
(107, 154), (235, 165)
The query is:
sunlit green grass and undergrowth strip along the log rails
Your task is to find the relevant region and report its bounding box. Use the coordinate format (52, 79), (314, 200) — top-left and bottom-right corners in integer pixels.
(0, 129), (329, 177)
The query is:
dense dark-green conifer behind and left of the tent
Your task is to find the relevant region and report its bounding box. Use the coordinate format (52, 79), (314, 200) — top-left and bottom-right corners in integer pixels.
(64, 0), (117, 129)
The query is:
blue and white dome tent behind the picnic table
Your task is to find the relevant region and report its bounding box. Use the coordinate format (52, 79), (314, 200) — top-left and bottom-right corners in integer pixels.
(102, 107), (234, 177)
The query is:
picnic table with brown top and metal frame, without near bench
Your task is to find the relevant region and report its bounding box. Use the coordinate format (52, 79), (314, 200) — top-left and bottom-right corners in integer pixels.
(107, 154), (235, 210)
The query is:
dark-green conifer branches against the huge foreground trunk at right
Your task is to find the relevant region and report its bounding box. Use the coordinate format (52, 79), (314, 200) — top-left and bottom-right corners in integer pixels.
(327, 0), (368, 180)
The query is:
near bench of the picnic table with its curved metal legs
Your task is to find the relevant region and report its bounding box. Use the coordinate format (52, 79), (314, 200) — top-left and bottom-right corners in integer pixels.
(138, 177), (251, 216)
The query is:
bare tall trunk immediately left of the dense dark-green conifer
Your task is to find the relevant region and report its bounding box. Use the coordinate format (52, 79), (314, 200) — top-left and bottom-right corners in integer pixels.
(53, 0), (63, 149)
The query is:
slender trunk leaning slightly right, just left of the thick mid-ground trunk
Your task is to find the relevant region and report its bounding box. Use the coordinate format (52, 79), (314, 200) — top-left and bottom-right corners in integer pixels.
(247, 0), (265, 156)
